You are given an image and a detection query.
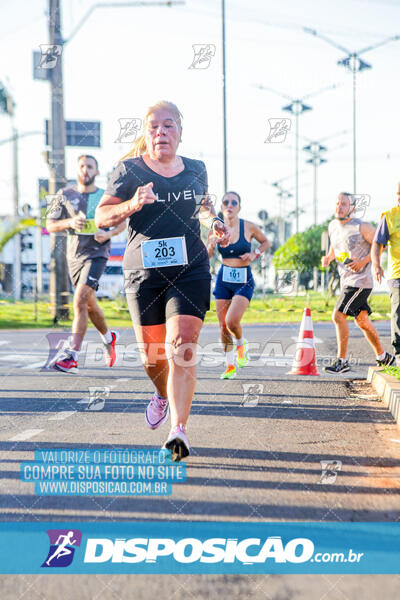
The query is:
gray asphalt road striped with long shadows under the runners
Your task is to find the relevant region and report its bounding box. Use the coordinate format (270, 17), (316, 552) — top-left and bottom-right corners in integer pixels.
(0, 321), (400, 600)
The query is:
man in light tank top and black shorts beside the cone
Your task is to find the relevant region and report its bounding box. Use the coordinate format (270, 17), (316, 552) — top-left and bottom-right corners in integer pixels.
(321, 192), (395, 373)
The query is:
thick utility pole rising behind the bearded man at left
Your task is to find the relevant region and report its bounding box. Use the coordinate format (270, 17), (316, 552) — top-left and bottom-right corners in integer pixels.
(49, 0), (69, 323)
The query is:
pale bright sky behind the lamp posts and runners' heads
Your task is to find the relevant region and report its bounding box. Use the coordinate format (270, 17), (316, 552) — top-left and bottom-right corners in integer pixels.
(0, 0), (400, 230)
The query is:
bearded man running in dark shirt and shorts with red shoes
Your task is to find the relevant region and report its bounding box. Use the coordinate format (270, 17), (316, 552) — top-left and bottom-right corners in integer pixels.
(46, 154), (125, 373)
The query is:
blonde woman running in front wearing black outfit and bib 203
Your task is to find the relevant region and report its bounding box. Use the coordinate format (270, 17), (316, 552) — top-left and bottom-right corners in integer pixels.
(96, 101), (229, 460)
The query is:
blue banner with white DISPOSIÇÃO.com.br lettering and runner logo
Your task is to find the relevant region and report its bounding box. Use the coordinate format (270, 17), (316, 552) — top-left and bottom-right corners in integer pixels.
(0, 521), (400, 574)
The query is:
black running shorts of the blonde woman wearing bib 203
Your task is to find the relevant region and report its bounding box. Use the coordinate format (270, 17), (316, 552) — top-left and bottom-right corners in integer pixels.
(126, 279), (211, 326)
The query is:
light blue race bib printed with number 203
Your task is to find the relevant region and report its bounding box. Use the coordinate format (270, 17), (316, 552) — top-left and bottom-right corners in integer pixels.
(142, 237), (187, 269)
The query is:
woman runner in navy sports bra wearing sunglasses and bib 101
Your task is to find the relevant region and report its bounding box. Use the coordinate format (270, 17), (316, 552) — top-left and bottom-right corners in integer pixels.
(207, 192), (270, 379)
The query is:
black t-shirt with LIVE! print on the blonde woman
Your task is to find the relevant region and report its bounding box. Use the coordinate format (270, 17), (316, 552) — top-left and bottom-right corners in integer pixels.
(105, 157), (210, 291)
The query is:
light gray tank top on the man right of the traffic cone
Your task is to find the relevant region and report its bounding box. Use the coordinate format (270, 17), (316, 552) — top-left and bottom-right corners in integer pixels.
(328, 218), (374, 289)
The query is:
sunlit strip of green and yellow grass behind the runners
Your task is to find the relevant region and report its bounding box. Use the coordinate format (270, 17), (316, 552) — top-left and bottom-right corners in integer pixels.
(0, 292), (390, 329)
